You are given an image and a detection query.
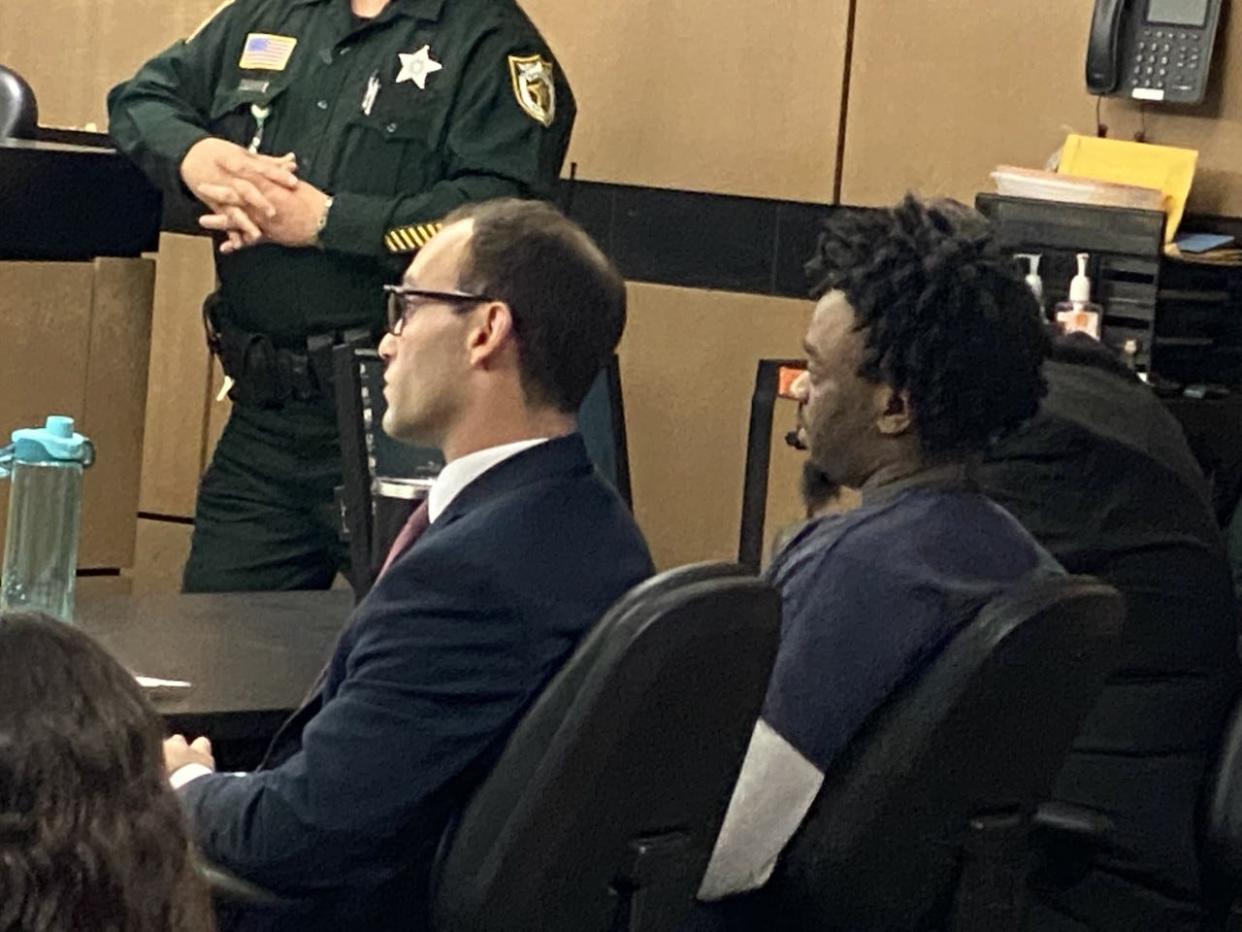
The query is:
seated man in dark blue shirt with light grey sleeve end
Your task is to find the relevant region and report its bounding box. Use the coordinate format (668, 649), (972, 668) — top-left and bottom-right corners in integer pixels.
(699, 198), (1061, 900)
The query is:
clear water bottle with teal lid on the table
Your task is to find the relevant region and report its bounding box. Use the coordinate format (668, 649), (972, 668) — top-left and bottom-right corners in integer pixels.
(0, 415), (94, 621)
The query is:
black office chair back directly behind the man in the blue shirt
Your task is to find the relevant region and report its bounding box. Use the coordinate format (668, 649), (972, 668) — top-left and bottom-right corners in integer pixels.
(764, 577), (1124, 932)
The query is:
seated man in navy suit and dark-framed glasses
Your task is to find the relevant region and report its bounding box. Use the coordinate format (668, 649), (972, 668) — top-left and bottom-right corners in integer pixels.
(165, 200), (652, 930)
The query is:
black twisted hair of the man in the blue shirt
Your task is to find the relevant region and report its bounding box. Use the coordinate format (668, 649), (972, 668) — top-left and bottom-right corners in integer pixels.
(806, 195), (1047, 459)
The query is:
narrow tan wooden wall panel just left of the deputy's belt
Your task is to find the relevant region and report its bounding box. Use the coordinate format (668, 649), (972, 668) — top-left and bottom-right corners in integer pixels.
(142, 234), (215, 517)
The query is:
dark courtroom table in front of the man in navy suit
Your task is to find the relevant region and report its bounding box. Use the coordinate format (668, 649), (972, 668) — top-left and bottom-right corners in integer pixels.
(77, 589), (354, 769)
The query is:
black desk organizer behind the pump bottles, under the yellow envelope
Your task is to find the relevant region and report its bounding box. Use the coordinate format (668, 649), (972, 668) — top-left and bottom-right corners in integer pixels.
(975, 194), (1165, 370)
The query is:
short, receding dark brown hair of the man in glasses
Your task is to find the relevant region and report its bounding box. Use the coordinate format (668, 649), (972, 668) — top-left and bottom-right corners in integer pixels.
(443, 198), (626, 413)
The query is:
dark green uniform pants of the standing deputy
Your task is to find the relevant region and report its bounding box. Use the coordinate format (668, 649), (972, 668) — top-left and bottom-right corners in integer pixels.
(181, 401), (348, 593)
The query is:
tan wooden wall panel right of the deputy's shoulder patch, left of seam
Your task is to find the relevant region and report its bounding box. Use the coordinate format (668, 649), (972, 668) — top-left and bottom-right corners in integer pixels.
(511, 0), (848, 201)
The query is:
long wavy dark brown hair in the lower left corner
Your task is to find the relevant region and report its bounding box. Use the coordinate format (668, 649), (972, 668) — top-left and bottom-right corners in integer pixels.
(0, 613), (214, 932)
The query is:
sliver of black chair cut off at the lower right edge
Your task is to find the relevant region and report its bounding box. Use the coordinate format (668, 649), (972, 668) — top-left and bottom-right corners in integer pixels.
(1201, 701), (1242, 932)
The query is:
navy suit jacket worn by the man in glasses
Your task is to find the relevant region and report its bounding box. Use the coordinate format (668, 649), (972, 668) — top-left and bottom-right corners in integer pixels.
(181, 434), (652, 930)
